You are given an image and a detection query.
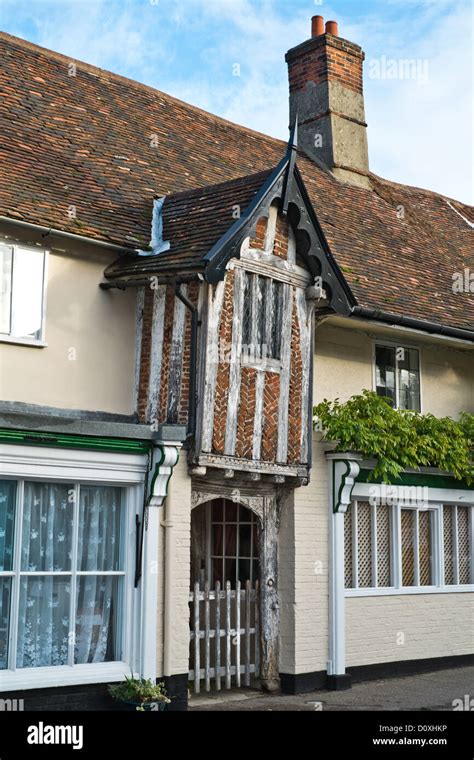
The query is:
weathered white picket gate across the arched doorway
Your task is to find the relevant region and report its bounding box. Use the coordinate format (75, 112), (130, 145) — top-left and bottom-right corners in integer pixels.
(189, 581), (260, 694)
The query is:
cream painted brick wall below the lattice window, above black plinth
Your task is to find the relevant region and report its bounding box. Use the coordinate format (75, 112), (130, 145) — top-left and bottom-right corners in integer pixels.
(346, 593), (474, 667)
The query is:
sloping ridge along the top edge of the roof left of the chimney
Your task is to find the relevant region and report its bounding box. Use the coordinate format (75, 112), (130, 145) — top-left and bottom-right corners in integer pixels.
(0, 30), (286, 145)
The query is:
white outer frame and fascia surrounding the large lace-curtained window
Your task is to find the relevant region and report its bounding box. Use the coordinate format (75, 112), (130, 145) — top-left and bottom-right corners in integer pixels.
(0, 445), (148, 693)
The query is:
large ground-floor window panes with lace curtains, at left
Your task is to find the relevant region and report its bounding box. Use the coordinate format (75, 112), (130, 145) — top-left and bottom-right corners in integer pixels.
(0, 479), (131, 672)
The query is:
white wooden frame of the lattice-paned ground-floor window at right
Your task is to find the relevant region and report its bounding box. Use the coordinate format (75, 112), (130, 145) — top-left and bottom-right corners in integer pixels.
(344, 490), (474, 597)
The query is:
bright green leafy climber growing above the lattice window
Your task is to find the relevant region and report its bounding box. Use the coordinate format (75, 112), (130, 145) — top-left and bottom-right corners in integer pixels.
(313, 390), (474, 484)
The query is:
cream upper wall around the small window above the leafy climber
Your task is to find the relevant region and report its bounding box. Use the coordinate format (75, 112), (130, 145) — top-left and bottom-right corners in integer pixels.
(314, 323), (474, 417)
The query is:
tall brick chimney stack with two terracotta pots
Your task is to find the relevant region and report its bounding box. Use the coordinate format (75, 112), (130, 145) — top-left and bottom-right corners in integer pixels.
(285, 16), (370, 187)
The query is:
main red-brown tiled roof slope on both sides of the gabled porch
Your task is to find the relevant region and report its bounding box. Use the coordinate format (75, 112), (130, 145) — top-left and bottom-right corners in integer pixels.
(0, 34), (474, 329)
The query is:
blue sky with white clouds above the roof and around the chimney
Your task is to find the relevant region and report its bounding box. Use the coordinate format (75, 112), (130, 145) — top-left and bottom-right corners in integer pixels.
(0, 0), (474, 203)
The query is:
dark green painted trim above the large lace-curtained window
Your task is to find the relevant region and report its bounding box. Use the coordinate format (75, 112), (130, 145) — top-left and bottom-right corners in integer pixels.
(0, 428), (152, 454)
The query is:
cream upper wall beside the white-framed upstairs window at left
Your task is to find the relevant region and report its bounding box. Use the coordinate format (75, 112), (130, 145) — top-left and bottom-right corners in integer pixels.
(0, 252), (136, 414)
